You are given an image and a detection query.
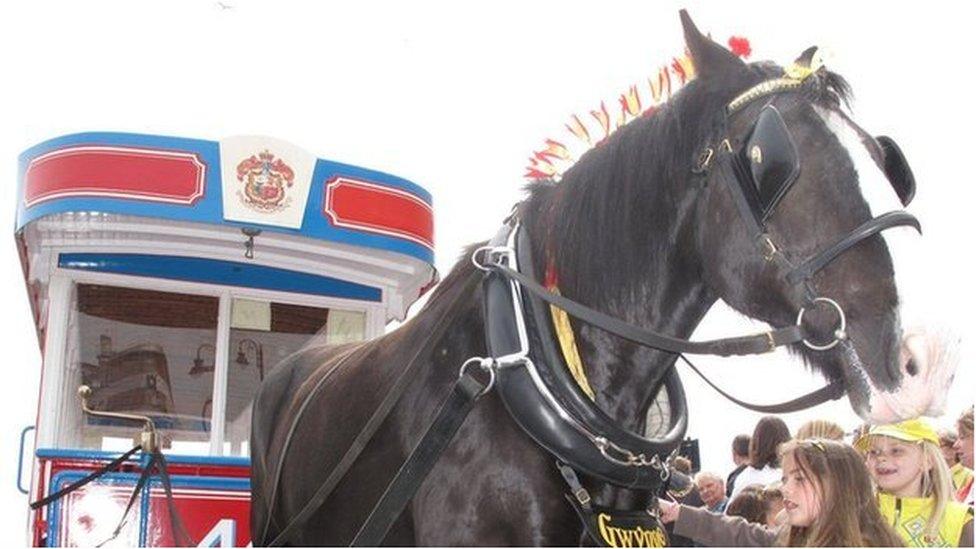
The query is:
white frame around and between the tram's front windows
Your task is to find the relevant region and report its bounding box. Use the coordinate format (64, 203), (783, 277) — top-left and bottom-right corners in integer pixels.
(37, 264), (390, 456)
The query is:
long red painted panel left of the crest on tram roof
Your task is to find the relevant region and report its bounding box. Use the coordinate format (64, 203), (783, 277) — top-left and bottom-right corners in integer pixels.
(24, 146), (206, 208)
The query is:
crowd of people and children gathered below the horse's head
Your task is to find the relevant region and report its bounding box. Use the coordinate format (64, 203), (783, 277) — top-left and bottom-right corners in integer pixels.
(658, 407), (974, 547)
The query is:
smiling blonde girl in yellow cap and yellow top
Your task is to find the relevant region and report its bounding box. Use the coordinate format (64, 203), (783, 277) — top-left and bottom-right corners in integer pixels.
(855, 419), (973, 547)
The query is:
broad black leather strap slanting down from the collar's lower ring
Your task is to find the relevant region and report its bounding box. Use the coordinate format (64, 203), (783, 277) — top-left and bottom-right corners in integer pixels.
(350, 373), (485, 547)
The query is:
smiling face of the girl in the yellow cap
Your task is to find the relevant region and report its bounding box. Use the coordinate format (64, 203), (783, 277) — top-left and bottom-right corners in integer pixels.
(867, 436), (925, 497)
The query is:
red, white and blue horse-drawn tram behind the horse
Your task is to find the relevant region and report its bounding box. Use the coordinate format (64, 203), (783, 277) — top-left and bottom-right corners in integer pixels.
(16, 133), (437, 546)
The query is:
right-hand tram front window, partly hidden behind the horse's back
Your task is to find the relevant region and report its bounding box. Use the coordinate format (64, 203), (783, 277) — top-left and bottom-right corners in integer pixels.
(224, 299), (366, 456)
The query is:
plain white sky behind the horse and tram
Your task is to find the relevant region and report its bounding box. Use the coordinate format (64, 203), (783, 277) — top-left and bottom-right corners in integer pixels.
(0, 0), (976, 543)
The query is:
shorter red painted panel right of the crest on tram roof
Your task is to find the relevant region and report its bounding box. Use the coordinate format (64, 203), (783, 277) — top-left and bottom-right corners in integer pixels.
(324, 177), (434, 249)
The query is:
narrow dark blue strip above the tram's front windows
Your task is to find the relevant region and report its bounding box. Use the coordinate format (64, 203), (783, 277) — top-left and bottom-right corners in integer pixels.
(58, 253), (382, 302)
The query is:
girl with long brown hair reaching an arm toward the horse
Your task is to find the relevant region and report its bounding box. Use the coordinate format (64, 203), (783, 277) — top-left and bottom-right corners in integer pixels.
(658, 439), (903, 547)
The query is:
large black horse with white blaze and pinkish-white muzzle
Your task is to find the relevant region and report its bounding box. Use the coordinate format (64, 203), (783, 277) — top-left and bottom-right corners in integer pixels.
(251, 11), (939, 546)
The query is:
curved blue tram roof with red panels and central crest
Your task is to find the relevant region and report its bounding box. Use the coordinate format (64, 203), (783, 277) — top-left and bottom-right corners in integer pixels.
(15, 132), (437, 328)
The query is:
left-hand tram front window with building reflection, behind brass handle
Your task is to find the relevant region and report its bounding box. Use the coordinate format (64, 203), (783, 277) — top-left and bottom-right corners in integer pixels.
(62, 284), (219, 454)
